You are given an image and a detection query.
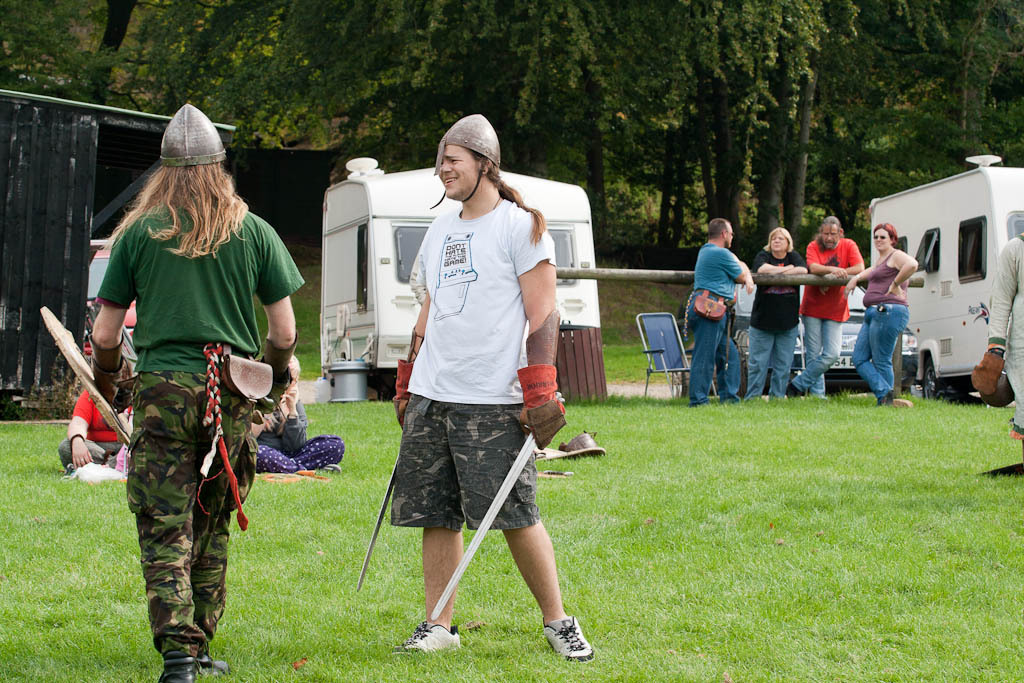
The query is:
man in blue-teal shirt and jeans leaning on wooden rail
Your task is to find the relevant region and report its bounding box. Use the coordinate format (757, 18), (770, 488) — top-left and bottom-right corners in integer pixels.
(686, 218), (754, 408)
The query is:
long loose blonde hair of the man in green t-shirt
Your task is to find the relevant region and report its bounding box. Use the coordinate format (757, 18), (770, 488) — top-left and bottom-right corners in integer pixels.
(111, 164), (249, 258)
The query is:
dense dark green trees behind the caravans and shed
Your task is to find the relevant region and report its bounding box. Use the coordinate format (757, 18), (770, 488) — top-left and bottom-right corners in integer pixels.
(0, 0), (1024, 259)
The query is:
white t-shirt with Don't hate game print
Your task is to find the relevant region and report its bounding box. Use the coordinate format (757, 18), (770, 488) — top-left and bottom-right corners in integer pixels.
(409, 200), (555, 404)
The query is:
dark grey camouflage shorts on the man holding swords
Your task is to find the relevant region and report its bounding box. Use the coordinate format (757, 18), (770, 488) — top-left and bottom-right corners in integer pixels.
(391, 395), (541, 531)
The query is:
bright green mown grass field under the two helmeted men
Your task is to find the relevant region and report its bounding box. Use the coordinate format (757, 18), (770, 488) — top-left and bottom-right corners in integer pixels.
(6, 396), (1024, 681)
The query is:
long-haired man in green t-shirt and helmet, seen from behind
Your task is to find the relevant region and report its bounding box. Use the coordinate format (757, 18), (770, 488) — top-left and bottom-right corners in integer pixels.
(92, 104), (303, 683)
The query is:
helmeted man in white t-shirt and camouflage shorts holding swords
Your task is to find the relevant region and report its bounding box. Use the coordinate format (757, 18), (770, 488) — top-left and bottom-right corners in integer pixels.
(391, 115), (593, 661)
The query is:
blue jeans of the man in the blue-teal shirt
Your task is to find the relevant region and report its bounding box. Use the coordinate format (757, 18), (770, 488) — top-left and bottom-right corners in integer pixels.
(686, 302), (739, 405)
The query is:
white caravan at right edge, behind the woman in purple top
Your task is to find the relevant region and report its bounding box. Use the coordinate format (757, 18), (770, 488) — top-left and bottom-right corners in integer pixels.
(870, 155), (1024, 397)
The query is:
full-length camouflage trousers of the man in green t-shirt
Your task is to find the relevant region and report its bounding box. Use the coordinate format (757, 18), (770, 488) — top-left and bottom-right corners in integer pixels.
(128, 371), (256, 655)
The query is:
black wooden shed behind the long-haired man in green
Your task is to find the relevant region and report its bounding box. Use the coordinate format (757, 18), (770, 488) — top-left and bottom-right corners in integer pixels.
(0, 90), (234, 391)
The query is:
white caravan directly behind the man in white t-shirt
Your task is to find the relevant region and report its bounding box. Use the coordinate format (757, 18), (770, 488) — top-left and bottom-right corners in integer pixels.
(321, 159), (601, 397)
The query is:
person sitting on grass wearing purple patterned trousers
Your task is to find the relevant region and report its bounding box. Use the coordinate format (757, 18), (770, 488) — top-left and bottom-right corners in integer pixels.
(253, 355), (345, 473)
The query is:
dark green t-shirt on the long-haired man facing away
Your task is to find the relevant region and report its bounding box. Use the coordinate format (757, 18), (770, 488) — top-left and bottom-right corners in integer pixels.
(99, 213), (304, 373)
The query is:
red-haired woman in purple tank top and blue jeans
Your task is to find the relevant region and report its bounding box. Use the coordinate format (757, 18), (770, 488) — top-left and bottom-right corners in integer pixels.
(846, 223), (918, 405)
